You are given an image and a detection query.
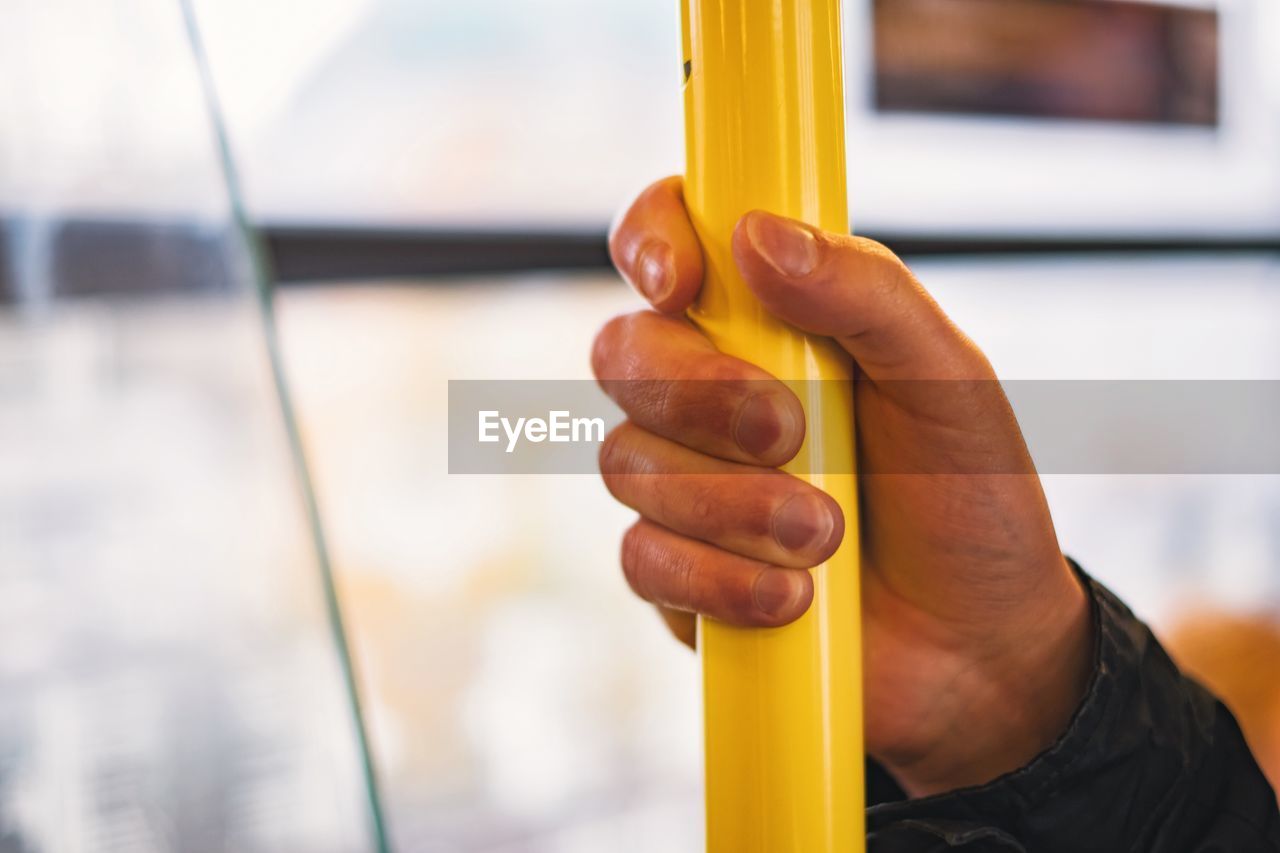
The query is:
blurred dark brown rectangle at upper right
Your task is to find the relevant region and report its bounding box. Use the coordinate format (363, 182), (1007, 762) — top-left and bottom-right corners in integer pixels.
(874, 0), (1219, 126)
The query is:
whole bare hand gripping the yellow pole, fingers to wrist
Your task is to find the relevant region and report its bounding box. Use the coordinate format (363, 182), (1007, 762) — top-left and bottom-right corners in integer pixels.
(591, 177), (1092, 797)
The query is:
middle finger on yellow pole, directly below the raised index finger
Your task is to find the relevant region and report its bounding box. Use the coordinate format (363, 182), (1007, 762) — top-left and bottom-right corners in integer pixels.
(591, 311), (804, 467)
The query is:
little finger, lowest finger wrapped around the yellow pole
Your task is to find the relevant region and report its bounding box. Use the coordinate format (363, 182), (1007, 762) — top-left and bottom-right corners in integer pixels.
(622, 520), (813, 628)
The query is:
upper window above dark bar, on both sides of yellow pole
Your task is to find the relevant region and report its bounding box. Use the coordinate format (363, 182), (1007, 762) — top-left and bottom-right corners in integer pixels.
(197, 0), (1280, 236)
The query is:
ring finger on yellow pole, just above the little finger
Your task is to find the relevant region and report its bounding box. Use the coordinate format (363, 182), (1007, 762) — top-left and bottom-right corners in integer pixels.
(600, 424), (845, 569)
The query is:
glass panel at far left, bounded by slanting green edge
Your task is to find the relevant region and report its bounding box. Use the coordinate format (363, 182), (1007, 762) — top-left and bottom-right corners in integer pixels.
(0, 0), (374, 853)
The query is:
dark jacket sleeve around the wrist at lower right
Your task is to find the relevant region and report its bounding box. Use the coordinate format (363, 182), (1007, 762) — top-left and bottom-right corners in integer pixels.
(867, 560), (1280, 853)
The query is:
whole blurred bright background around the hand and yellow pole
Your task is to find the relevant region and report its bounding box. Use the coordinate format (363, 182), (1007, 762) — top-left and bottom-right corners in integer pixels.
(0, 0), (1280, 853)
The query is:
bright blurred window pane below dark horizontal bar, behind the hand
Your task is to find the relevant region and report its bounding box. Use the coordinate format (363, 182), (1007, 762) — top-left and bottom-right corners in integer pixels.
(267, 256), (1280, 853)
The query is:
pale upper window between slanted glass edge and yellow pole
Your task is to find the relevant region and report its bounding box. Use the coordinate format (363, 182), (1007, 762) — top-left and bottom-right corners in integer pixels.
(197, 0), (684, 228)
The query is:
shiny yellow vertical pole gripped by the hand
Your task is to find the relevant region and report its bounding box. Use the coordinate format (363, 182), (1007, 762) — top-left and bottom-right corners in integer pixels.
(682, 0), (865, 853)
